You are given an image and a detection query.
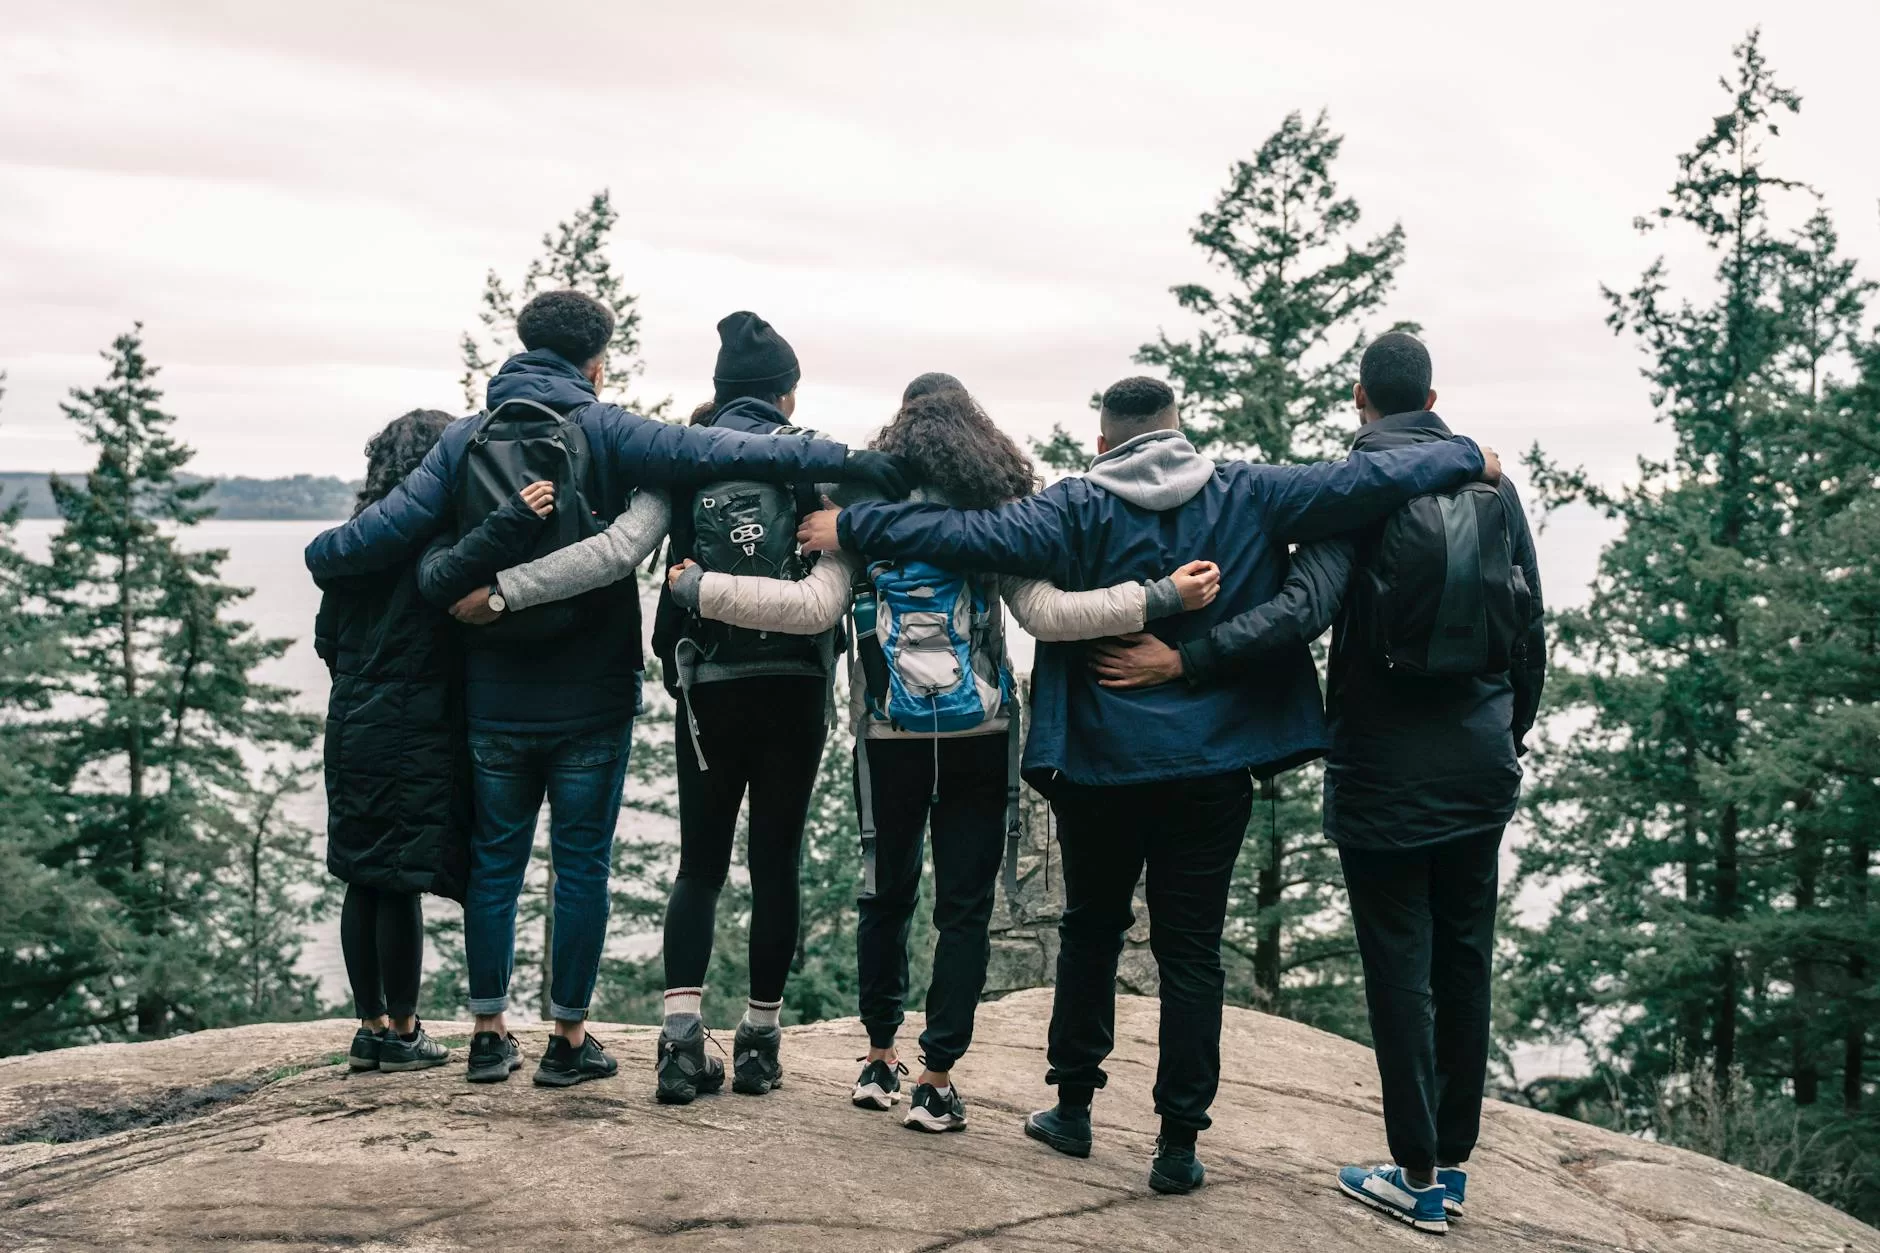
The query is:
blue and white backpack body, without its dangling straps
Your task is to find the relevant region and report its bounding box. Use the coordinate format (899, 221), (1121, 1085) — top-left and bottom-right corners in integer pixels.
(857, 561), (1011, 734)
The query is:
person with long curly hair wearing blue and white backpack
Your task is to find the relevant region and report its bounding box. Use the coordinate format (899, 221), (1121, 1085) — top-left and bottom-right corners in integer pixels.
(669, 374), (1218, 1133)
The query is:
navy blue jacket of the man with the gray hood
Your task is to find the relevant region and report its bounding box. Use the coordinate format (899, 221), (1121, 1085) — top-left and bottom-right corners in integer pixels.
(838, 433), (1481, 792)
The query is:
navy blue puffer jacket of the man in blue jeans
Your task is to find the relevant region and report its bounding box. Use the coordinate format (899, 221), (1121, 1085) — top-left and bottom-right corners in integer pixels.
(306, 350), (848, 732)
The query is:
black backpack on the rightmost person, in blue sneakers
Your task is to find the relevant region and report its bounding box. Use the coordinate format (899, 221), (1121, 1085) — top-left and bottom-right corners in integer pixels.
(1352, 482), (1530, 675)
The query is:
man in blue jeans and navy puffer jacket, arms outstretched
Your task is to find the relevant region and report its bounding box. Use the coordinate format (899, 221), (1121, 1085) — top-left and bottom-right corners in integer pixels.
(306, 292), (906, 1087)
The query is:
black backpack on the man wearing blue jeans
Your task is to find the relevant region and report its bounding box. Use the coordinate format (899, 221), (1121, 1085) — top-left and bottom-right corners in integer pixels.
(455, 401), (607, 645)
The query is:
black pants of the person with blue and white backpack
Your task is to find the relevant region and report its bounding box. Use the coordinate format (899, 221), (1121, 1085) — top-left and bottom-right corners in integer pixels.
(855, 732), (1010, 1071)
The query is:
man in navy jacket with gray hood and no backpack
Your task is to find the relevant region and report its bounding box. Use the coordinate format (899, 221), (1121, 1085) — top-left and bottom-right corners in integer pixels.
(803, 378), (1500, 1193)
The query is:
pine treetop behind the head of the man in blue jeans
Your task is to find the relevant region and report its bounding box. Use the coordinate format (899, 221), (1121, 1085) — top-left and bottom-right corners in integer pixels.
(461, 190), (673, 420)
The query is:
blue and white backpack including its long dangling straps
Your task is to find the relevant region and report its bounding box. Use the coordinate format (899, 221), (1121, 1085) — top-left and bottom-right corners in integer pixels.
(852, 561), (1023, 909)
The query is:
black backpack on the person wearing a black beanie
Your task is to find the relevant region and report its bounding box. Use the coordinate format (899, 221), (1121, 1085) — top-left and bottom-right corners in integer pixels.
(686, 474), (827, 670)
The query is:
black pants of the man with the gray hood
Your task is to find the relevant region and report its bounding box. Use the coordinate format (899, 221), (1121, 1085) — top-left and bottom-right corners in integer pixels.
(1045, 771), (1254, 1131)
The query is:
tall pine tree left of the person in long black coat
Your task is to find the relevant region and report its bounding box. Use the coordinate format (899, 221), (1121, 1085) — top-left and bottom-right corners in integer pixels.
(43, 327), (314, 1037)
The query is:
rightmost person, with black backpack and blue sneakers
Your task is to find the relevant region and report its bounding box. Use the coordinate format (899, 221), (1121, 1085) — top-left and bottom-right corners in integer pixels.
(1094, 331), (1547, 1232)
